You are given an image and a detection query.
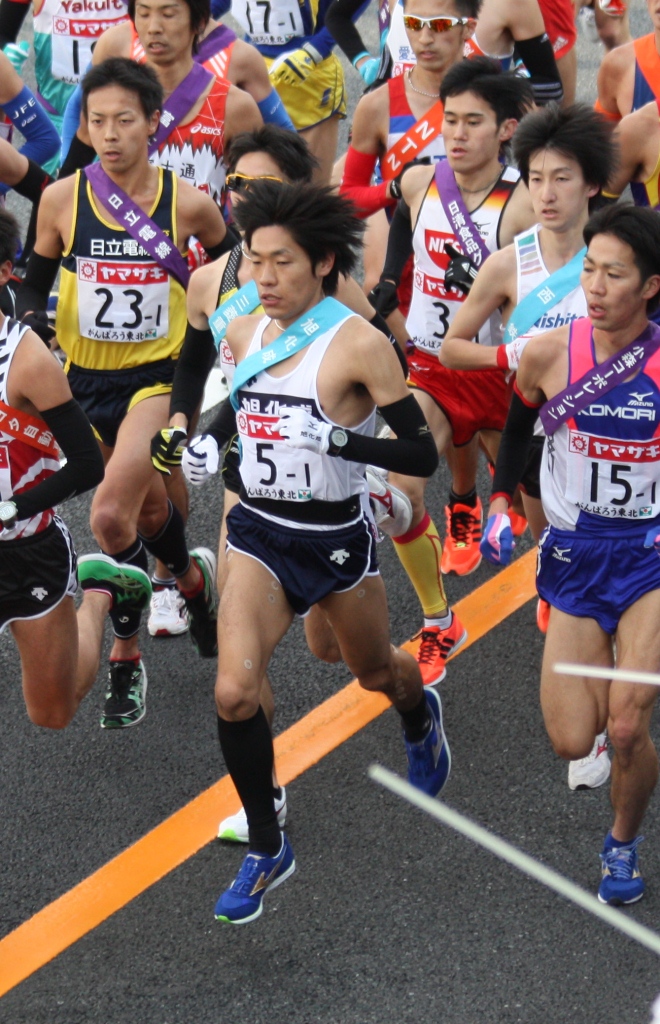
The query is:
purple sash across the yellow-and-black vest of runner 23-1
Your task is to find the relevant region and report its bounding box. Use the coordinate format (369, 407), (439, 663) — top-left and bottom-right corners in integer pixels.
(85, 164), (190, 290)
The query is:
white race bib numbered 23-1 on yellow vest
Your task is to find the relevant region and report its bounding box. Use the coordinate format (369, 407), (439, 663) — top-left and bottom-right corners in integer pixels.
(76, 257), (170, 343)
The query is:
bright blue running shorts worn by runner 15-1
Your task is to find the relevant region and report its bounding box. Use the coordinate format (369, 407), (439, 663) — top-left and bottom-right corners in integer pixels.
(536, 526), (660, 634)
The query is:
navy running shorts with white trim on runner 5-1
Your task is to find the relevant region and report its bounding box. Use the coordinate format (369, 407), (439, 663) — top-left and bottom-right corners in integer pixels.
(227, 504), (378, 615)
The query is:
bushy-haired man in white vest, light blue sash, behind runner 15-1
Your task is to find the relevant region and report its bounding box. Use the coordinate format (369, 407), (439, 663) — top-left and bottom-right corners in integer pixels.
(440, 105), (616, 790)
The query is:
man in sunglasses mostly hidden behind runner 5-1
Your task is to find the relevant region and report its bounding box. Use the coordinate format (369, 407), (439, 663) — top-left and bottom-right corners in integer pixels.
(151, 125), (409, 843)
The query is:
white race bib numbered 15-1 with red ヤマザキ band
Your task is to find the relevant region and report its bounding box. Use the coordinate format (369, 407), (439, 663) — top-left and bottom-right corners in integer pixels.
(566, 430), (660, 519)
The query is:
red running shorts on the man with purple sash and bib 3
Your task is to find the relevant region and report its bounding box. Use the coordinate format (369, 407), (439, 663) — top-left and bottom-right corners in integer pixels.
(408, 348), (511, 447)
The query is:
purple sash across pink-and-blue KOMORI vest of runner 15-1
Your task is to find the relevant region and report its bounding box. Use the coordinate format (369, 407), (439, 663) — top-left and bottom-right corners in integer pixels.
(538, 317), (660, 437)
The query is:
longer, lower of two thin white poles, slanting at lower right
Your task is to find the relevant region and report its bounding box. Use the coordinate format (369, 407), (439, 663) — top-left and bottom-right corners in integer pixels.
(369, 765), (660, 956)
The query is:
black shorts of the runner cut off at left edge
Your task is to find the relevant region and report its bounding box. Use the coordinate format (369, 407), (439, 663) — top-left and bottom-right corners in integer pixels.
(0, 516), (78, 633)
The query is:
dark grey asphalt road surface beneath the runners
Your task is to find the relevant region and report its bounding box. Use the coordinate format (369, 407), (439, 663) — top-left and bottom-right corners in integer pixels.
(0, 0), (660, 1024)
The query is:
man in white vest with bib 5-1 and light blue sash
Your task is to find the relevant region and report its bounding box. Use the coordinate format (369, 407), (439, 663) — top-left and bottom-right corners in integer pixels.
(209, 181), (449, 924)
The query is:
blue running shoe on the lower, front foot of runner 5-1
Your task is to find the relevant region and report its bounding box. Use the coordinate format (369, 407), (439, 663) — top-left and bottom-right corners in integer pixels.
(215, 833), (296, 925)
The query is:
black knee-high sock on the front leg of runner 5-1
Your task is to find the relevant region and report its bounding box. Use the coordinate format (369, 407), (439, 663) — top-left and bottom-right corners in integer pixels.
(218, 707), (281, 857)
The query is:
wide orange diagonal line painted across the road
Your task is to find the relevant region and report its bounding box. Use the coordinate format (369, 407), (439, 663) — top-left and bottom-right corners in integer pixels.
(0, 551), (535, 996)
